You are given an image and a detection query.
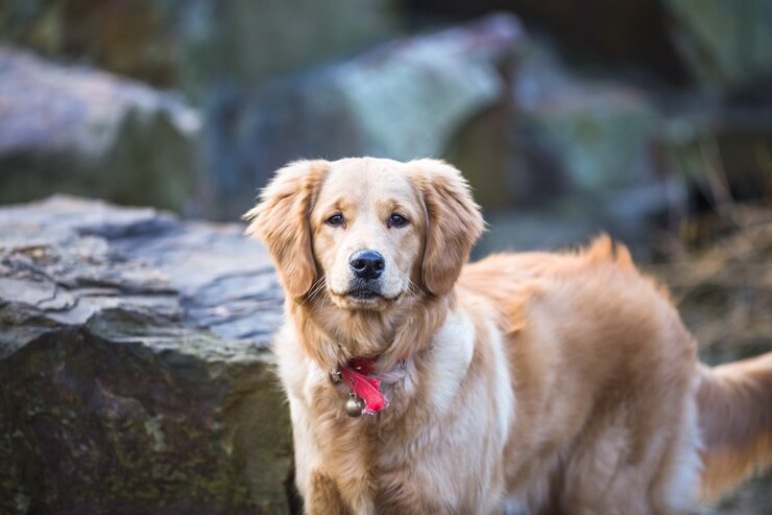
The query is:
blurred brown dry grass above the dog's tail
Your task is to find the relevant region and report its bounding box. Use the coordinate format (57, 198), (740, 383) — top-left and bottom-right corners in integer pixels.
(651, 205), (772, 363)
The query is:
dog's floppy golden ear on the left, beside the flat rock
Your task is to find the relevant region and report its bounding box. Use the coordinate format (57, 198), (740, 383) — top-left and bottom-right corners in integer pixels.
(244, 160), (329, 298)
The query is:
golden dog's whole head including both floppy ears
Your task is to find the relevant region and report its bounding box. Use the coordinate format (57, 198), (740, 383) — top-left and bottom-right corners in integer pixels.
(245, 158), (483, 310)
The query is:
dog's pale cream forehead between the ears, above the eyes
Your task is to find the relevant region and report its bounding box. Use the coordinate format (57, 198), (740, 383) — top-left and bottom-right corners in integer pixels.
(321, 159), (417, 204)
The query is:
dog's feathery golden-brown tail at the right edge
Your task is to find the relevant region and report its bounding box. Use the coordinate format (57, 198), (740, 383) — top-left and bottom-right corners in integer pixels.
(697, 352), (772, 500)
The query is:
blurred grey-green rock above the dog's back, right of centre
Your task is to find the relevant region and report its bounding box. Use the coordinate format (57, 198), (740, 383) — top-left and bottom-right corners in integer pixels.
(515, 40), (662, 198)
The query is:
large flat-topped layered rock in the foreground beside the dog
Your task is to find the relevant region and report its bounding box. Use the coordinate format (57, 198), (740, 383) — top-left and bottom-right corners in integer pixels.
(0, 197), (292, 514)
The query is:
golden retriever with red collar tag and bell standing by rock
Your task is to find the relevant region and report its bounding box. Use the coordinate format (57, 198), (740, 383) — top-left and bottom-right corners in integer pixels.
(245, 158), (772, 515)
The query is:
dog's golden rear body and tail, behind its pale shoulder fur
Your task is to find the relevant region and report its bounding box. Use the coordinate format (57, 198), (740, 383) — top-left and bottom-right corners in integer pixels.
(460, 237), (772, 513)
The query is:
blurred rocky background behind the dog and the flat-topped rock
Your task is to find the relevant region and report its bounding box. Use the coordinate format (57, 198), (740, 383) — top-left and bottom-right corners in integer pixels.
(0, 0), (772, 513)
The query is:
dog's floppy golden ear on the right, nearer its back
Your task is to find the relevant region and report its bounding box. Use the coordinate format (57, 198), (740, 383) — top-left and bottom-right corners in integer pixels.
(409, 159), (485, 295)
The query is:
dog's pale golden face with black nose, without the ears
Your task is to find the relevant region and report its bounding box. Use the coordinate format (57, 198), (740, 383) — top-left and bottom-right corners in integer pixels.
(310, 160), (426, 309)
